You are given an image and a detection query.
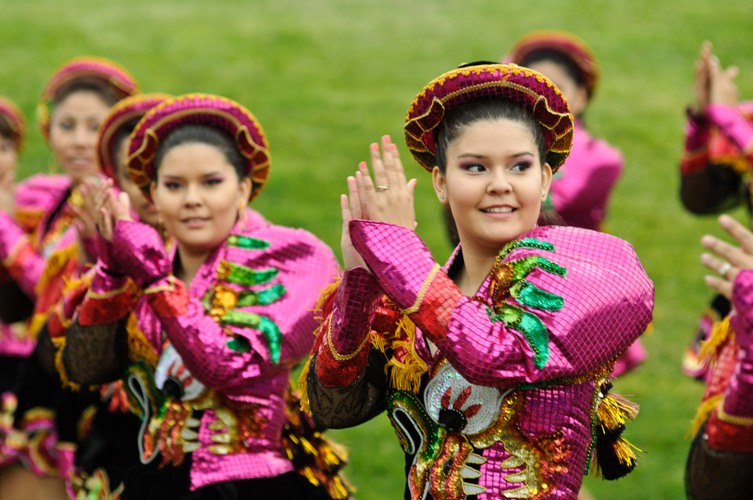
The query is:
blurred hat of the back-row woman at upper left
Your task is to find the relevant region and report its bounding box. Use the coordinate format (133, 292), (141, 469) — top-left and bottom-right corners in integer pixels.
(37, 57), (138, 139)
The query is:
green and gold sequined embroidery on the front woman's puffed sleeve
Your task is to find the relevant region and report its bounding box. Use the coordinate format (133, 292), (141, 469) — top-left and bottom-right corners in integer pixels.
(487, 238), (567, 368)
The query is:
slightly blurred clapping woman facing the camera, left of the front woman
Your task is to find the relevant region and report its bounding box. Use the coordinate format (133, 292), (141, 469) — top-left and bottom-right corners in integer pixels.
(61, 94), (349, 499)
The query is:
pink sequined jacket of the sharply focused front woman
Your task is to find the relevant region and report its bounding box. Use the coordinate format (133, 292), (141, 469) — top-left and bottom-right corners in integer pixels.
(303, 224), (653, 499)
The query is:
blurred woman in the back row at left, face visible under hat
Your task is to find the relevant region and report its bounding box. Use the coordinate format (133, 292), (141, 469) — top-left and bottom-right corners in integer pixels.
(0, 57), (137, 498)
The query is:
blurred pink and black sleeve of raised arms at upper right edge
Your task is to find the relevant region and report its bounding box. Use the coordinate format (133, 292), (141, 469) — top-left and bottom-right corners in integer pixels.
(680, 102), (753, 214)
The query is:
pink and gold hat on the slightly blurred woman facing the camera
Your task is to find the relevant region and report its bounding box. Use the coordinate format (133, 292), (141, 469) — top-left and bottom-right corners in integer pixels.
(127, 94), (270, 201)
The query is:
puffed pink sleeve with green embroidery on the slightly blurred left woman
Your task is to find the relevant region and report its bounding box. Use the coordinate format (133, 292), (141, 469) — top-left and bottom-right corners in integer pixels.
(160, 226), (337, 393)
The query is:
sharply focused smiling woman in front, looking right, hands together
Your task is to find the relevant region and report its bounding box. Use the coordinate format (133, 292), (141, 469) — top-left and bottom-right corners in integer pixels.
(301, 63), (653, 500)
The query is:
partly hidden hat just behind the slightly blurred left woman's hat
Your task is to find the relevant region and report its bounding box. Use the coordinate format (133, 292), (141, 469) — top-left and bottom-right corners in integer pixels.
(97, 94), (170, 182)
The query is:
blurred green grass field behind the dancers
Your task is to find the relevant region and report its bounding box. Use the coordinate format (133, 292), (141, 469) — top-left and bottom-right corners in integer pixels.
(0, 0), (753, 500)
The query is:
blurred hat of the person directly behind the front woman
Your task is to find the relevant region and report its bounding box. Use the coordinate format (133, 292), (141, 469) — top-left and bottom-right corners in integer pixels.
(505, 31), (599, 97)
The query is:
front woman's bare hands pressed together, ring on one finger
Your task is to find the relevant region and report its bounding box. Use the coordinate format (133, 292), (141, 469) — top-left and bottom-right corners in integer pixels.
(340, 136), (416, 269)
